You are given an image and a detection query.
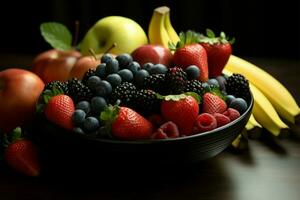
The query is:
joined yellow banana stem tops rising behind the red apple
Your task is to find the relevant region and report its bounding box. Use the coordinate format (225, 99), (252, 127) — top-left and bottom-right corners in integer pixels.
(148, 6), (179, 48)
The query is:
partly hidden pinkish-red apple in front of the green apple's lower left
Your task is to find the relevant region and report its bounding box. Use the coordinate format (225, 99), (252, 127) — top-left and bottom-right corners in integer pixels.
(69, 55), (102, 80)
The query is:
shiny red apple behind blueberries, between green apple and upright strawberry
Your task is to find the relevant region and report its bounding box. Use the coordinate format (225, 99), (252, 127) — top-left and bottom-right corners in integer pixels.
(131, 44), (173, 67)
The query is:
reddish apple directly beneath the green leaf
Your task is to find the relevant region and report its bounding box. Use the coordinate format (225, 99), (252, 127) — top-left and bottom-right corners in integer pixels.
(32, 49), (81, 83)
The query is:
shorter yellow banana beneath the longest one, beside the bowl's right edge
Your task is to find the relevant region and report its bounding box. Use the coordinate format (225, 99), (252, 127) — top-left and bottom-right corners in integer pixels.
(249, 83), (288, 136)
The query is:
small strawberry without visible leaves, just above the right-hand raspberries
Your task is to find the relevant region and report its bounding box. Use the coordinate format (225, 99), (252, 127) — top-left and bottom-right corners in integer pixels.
(202, 92), (227, 114)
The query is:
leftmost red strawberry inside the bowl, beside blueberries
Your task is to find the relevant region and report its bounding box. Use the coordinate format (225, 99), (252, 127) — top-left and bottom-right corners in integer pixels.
(45, 94), (75, 130)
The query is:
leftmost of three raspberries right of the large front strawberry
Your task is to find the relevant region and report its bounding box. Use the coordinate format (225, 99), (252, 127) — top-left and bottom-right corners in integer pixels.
(196, 113), (217, 133)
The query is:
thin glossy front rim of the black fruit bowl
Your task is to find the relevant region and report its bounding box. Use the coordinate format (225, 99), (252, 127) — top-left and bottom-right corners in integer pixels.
(69, 91), (254, 145)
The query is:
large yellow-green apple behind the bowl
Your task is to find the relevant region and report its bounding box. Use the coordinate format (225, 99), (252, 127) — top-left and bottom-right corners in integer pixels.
(80, 16), (148, 55)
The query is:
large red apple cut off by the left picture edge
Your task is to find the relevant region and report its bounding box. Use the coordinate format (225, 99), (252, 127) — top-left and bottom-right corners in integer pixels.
(0, 68), (44, 133)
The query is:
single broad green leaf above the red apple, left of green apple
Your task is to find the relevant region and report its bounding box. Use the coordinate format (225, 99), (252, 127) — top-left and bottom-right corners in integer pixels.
(40, 22), (72, 51)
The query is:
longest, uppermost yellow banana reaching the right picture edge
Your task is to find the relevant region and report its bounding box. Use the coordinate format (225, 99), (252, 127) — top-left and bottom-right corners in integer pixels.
(225, 55), (300, 124)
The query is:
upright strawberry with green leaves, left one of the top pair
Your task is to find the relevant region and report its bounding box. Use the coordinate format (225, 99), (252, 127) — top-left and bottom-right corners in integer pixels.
(170, 31), (208, 82)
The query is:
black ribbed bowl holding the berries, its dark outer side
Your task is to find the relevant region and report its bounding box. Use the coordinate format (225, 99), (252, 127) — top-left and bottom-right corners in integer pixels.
(32, 93), (253, 175)
